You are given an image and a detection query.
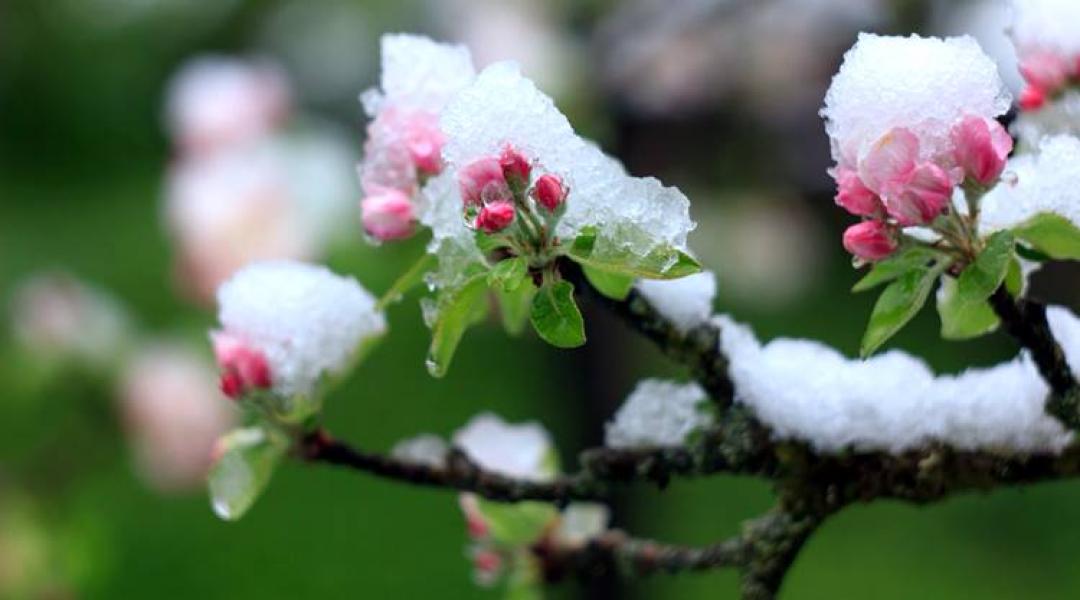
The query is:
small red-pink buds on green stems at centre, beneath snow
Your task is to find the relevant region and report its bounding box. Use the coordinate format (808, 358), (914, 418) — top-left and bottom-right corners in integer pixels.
(458, 146), (568, 256)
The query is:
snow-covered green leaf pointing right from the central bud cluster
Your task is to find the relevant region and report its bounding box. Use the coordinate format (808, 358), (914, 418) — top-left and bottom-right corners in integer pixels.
(566, 227), (701, 279)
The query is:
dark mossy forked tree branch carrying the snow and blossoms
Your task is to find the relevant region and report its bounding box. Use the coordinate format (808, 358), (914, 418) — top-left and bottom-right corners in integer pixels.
(300, 262), (1080, 600)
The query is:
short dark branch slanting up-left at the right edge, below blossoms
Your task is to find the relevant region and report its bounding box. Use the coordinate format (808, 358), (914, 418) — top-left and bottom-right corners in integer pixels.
(990, 286), (1080, 429)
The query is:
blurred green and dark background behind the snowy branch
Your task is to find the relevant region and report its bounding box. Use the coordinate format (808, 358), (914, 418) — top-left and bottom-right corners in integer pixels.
(0, 0), (1080, 599)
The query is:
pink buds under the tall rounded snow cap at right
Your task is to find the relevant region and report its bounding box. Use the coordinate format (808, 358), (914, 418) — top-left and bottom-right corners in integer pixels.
(834, 115), (1013, 261)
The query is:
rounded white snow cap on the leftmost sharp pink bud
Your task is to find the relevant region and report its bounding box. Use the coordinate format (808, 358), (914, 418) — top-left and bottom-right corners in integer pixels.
(215, 261), (387, 397)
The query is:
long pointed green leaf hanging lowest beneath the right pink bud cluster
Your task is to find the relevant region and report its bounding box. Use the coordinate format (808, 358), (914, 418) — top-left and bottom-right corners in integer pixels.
(859, 260), (948, 358)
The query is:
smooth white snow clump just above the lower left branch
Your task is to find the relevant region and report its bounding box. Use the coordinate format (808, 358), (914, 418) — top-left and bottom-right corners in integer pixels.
(454, 412), (555, 481)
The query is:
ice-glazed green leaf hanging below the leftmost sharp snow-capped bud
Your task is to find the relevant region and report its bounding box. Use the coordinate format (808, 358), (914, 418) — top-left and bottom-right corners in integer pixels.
(208, 425), (288, 521)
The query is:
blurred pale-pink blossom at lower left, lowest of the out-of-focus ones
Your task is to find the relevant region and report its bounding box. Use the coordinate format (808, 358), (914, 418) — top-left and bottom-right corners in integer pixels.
(120, 345), (234, 492)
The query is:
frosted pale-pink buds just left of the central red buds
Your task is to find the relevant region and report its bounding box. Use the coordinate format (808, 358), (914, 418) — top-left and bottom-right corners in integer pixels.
(360, 108), (446, 242)
